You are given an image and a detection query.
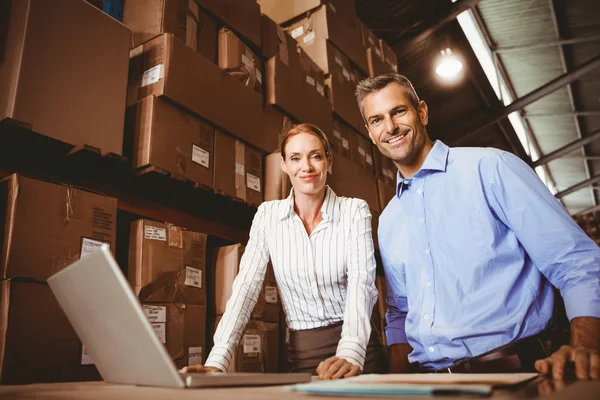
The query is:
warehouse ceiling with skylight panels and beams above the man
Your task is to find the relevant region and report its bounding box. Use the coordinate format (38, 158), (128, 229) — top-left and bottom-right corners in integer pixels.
(356, 0), (600, 214)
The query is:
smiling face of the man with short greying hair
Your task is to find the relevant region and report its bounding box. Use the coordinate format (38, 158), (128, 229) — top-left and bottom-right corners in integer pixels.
(363, 82), (428, 166)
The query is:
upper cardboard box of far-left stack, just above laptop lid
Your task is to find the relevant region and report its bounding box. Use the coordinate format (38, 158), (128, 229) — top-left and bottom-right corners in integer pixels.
(0, 174), (117, 282)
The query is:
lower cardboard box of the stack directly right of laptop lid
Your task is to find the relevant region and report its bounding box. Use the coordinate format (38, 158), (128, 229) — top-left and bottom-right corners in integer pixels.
(142, 303), (206, 369)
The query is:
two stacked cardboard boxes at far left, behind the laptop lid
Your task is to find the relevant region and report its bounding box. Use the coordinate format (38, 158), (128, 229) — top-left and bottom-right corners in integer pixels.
(0, 175), (117, 383)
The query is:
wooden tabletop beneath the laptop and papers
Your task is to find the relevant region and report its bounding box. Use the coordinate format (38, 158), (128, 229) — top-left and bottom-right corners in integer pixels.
(0, 378), (600, 400)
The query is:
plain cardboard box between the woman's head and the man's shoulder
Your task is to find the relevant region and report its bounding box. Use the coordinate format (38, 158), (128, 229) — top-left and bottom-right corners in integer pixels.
(327, 151), (381, 212)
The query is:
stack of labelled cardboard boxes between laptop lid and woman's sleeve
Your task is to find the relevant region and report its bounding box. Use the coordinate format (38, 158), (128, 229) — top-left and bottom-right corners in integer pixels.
(128, 220), (207, 368)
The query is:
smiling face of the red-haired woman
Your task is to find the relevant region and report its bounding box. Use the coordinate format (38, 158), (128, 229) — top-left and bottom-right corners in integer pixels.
(281, 133), (329, 195)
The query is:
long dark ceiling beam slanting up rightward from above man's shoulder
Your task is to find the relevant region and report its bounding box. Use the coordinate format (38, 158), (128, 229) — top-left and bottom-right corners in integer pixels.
(456, 54), (600, 143)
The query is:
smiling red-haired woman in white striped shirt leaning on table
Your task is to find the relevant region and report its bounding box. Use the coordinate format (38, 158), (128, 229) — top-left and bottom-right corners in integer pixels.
(186, 124), (388, 379)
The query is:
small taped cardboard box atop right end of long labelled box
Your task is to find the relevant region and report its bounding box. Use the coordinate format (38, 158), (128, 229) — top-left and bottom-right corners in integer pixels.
(218, 28), (263, 93)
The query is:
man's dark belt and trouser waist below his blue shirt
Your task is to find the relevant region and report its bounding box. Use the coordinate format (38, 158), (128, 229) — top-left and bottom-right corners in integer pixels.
(422, 335), (548, 373)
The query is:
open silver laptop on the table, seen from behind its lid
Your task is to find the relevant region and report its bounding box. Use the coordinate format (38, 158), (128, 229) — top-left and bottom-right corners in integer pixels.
(48, 246), (311, 388)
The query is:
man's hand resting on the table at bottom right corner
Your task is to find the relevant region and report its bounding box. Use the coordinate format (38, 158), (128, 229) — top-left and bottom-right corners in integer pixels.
(535, 345), (600, 379)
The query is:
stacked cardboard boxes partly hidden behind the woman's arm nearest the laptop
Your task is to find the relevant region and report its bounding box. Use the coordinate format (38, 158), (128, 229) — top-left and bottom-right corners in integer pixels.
(213, 244), (281, 372)
